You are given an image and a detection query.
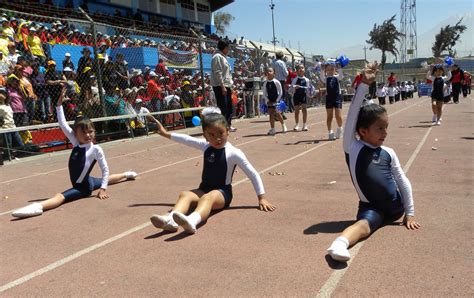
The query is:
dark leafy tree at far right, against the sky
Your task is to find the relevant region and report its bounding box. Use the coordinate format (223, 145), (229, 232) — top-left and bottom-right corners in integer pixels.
(431, 18), (467, 57)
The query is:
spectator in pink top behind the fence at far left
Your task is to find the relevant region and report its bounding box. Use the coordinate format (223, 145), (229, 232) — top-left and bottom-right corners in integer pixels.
(7, 74), (28, 126)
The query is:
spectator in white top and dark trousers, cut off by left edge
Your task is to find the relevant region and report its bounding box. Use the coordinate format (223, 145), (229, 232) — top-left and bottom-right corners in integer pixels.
(0, 87), (24, 154)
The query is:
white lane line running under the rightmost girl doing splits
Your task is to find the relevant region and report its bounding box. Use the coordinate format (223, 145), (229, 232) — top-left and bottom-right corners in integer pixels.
(316, 127), (433, 298)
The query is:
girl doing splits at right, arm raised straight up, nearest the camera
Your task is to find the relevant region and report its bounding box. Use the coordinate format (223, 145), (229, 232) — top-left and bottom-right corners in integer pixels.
(328, 63), (420, 261)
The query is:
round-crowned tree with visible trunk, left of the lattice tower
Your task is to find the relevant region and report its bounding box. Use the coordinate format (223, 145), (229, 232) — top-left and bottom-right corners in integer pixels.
(366, 15), (401, 69)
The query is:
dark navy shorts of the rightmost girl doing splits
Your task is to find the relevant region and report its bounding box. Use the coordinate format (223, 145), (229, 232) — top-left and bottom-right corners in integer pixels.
(357, 200), (405, 233)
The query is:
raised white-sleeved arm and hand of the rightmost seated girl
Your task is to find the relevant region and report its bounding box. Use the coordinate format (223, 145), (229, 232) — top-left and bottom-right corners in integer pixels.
(343, 63), (378, 153)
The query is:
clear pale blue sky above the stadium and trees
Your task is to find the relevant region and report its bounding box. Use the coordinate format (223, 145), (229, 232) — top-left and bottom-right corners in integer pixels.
(221, 0), (474, 59)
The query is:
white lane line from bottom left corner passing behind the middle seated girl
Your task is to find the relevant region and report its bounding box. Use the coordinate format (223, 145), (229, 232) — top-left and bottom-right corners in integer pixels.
(0, 100), (426, 293)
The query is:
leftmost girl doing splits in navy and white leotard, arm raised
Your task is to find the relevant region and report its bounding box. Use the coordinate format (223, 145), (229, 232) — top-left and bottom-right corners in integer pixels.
(12, 86), (137, 218)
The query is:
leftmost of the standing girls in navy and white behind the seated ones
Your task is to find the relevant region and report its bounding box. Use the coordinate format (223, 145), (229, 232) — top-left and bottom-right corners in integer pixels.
(262, 67), (288, 136)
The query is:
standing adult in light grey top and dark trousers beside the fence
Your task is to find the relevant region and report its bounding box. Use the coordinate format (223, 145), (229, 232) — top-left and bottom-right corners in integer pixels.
(210, 40), (235, 131)
